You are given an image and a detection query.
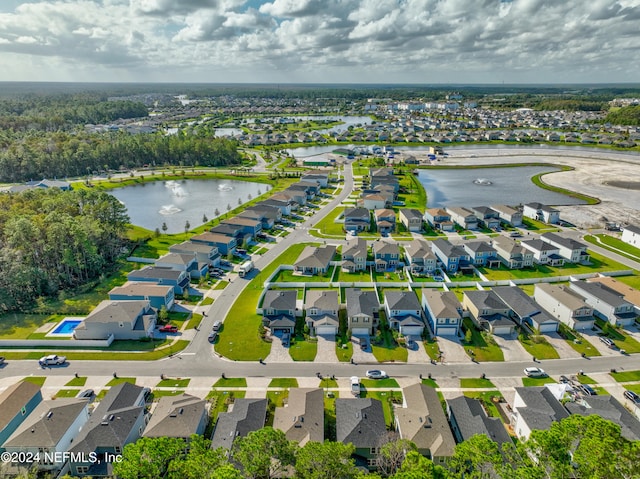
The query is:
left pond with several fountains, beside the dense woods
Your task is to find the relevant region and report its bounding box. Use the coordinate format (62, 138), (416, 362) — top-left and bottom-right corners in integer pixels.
(110, 180), (271, 233)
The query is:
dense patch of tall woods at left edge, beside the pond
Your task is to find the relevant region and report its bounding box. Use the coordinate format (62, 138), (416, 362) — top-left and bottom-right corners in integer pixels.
(0, 188), (129, 311)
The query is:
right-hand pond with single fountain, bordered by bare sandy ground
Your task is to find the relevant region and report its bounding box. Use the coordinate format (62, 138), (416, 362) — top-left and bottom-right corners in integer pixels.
(418, 166), (585, 208)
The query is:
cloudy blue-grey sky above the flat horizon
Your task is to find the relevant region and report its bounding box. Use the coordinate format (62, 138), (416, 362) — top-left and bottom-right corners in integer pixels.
(0, 0), (640, 84)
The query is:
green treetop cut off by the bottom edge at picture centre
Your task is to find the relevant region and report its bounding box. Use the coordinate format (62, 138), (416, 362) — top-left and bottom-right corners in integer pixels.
(296, 441), (358, 479)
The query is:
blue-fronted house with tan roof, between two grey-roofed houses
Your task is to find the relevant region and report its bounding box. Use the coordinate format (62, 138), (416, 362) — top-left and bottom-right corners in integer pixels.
(422, 288), (463, 336)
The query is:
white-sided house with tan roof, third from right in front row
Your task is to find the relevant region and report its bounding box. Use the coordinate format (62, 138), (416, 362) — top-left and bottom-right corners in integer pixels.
(533, 283), (595, 331)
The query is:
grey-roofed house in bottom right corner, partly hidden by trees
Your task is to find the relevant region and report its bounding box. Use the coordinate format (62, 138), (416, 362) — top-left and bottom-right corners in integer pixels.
(565, 395), (640, 441)
